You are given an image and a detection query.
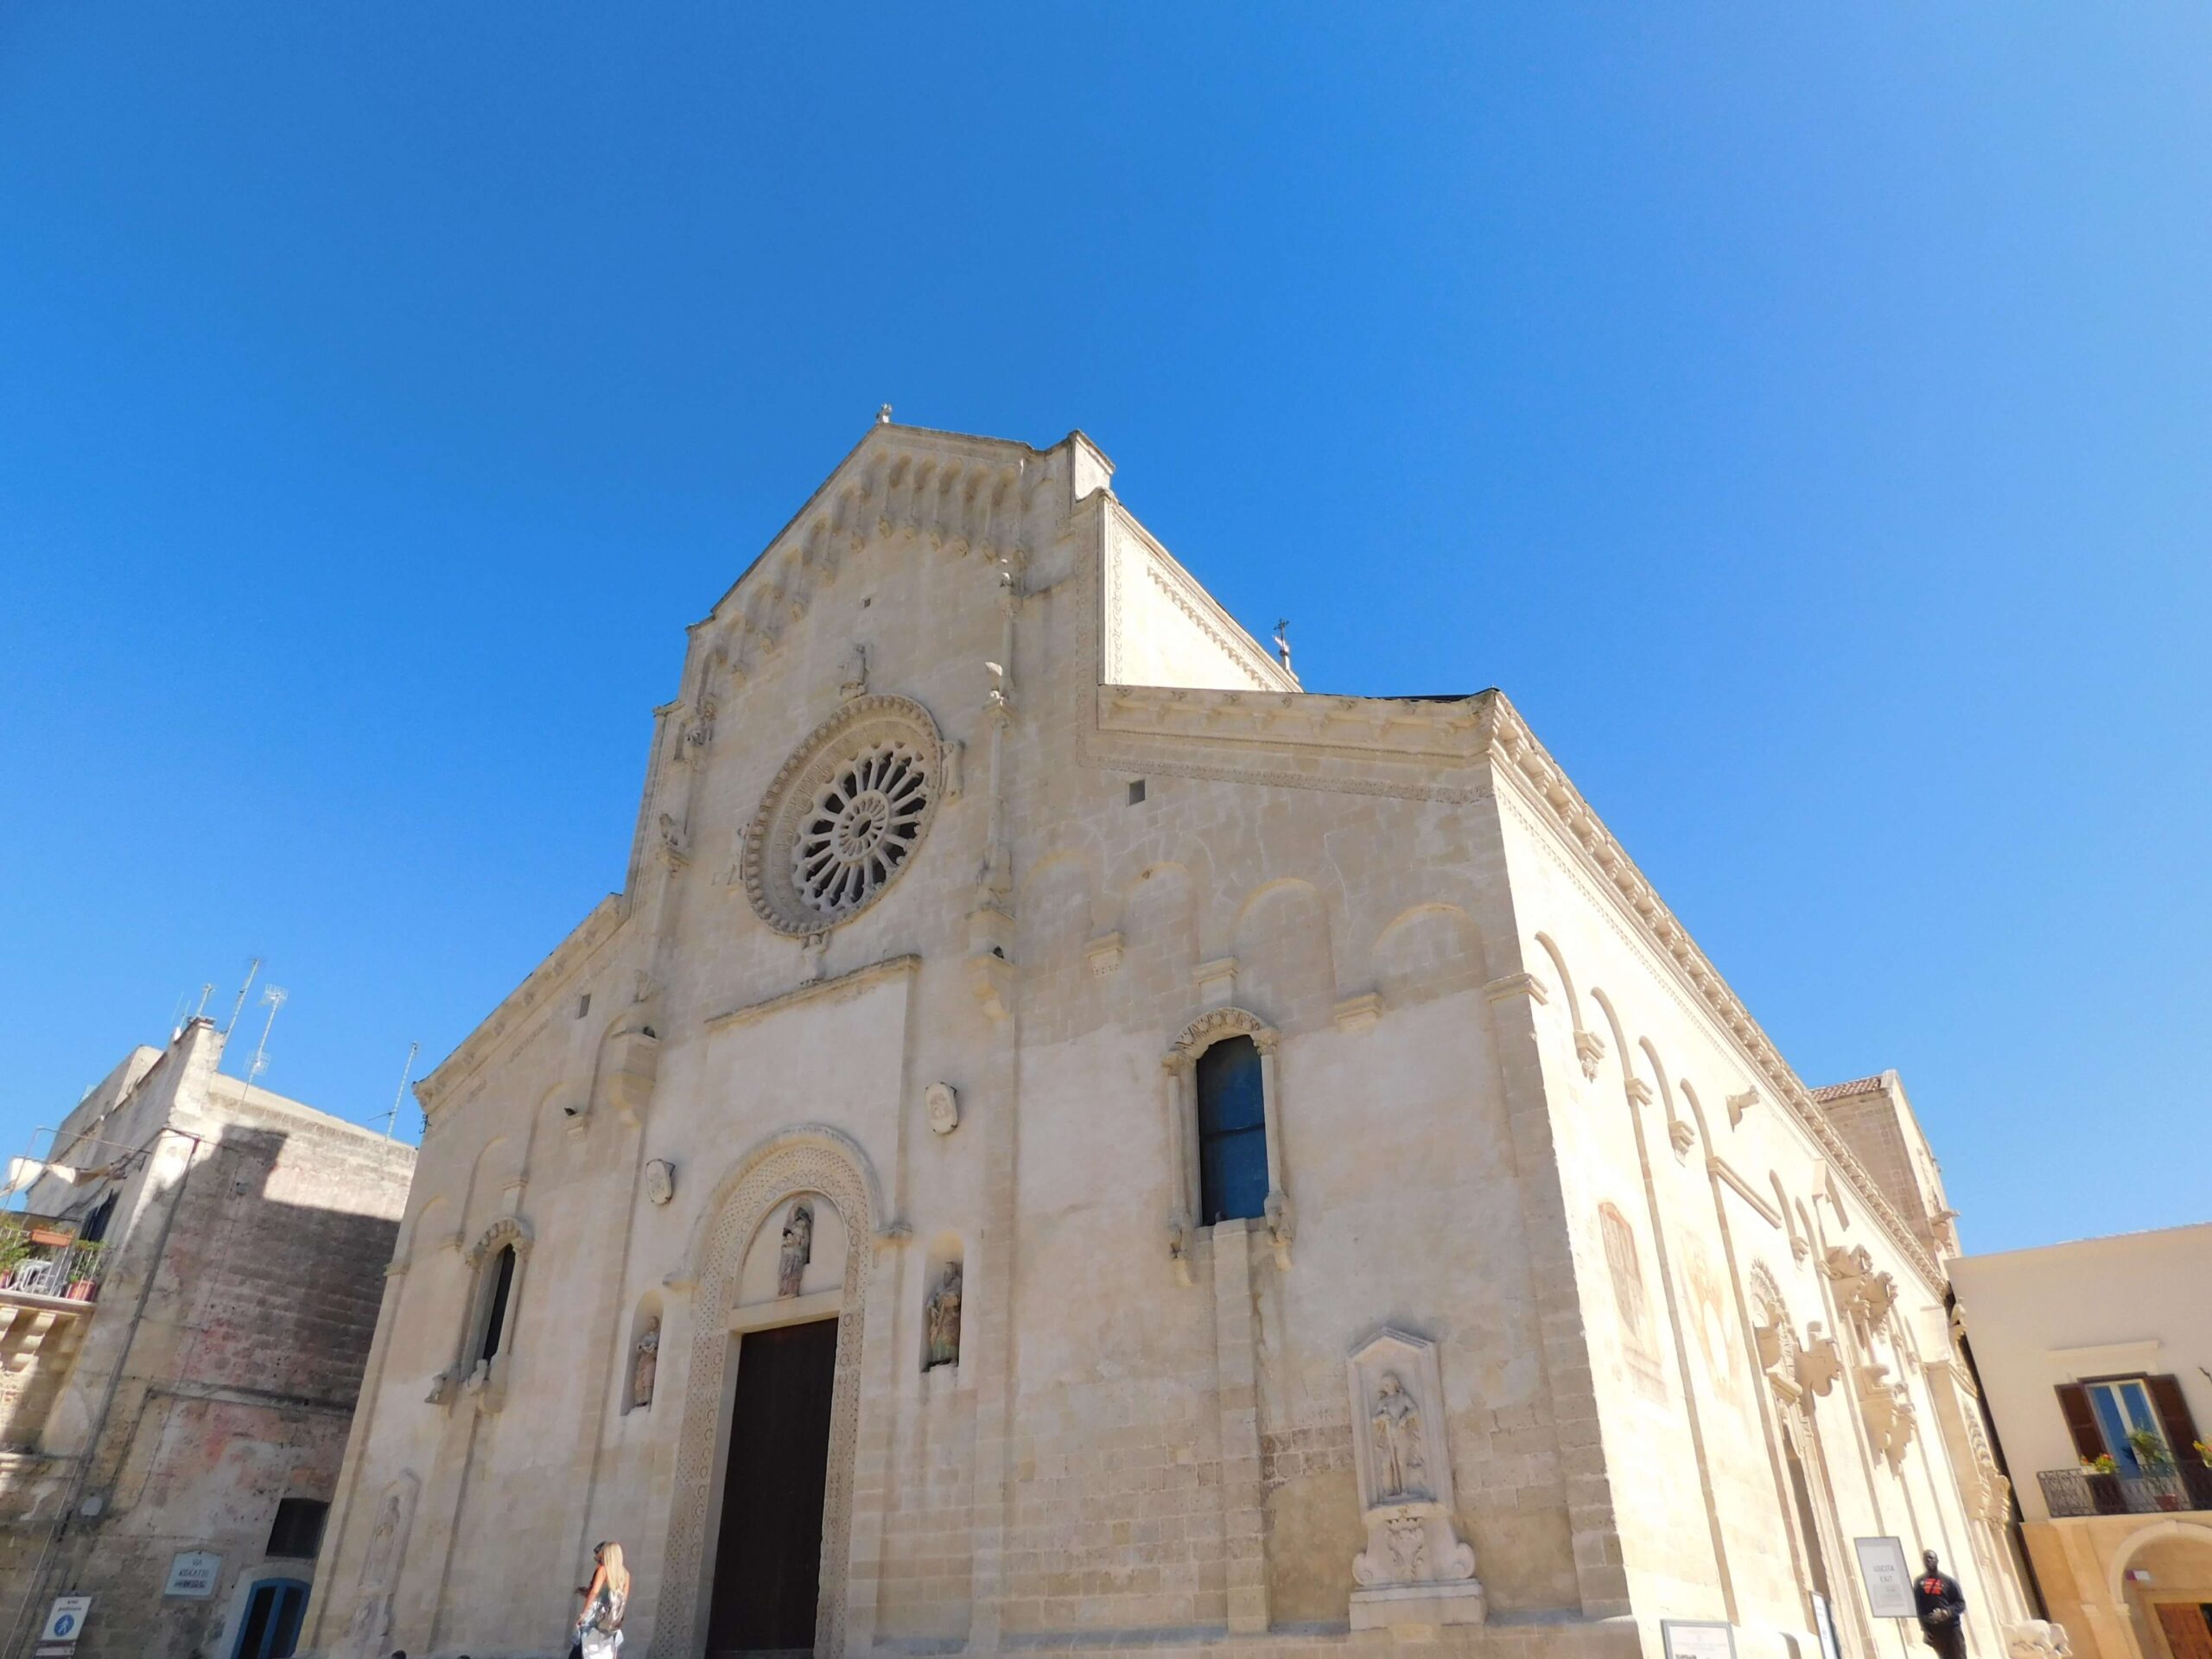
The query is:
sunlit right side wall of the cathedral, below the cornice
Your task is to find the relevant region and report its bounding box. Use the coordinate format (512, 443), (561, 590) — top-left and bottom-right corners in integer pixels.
(1502, 785), (2024, 1659)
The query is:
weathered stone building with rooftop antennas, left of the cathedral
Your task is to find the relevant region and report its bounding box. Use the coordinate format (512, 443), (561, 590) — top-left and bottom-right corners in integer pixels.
(0, 1020), (414, 1659)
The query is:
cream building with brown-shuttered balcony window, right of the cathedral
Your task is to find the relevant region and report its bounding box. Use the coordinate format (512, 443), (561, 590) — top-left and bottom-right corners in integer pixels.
(1951, 1224), (2212, 1659)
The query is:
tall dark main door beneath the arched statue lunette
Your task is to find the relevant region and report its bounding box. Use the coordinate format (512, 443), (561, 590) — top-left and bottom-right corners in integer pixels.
(706, 1319), (836, 1655)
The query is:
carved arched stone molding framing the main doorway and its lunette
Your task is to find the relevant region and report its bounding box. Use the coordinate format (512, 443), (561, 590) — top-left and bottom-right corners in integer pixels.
(646, 1130), (878, 1659)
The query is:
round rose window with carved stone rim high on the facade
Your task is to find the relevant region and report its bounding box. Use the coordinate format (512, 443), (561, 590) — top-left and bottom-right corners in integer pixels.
(741, 696), (944, 938)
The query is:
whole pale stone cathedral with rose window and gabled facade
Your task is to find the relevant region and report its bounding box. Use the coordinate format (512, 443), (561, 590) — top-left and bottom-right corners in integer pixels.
(303, 418), (2050, 1659)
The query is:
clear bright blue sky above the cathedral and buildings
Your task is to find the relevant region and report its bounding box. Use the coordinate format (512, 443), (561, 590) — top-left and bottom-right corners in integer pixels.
(0, 0), (2212, 1249)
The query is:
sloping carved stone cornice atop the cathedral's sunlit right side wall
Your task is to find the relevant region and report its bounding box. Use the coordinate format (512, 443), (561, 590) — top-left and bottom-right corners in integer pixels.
(1489, 692), (1944, 1289)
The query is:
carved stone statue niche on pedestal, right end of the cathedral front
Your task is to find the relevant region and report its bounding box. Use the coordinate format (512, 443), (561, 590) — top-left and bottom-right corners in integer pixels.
(1344, 1325), (1489, 1630)
